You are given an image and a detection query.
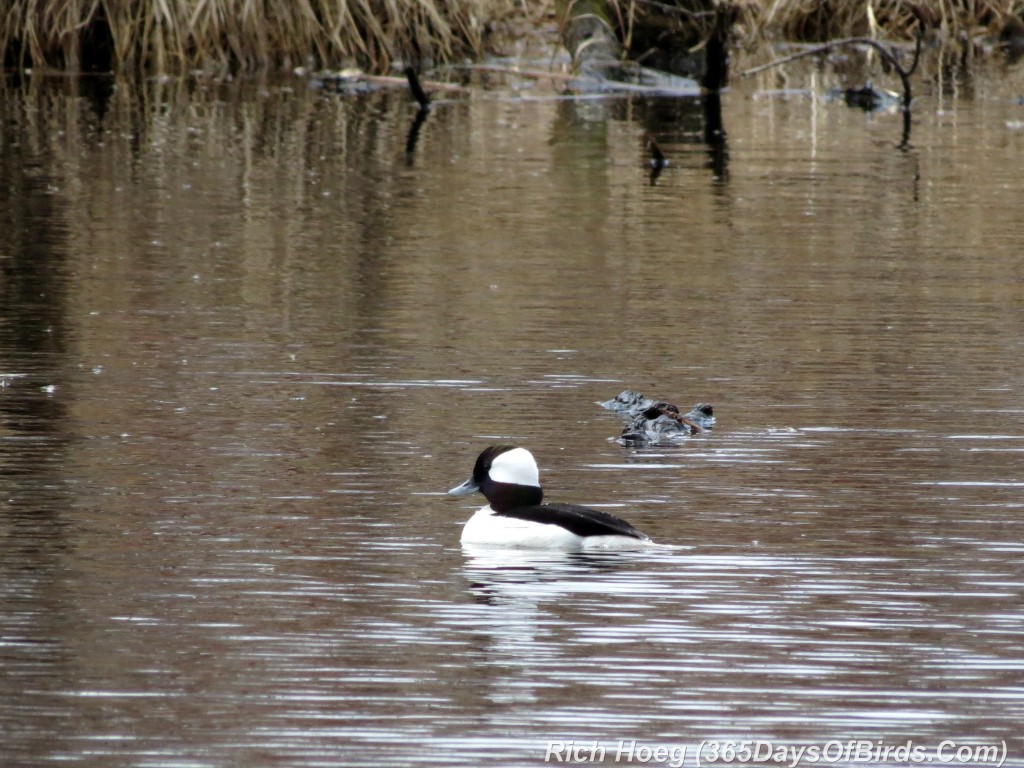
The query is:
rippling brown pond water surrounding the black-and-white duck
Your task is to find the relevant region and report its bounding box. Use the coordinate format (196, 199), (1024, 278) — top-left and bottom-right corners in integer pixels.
(0, 61), (1024, 767)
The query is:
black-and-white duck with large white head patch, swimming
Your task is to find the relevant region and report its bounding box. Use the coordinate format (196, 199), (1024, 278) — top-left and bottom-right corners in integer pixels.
(449, 445), (653, 551)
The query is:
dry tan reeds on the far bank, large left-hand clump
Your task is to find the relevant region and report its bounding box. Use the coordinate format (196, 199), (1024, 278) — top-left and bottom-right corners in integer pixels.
(0, 0), (514, 74)
